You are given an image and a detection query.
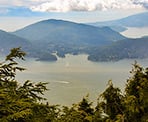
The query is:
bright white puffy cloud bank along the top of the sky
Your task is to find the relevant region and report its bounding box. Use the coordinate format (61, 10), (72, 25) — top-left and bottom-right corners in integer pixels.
(30, 0), (148, 12)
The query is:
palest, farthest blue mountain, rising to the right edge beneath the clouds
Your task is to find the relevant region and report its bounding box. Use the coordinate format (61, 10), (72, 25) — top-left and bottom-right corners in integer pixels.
(89, 12), (148, 32)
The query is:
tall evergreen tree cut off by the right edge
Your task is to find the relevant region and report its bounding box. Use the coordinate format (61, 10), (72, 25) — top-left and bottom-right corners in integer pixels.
(125, 62), (148, 122)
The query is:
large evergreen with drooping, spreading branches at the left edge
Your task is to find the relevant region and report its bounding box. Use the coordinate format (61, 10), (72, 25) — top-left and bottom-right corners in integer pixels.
(0, 48), (51, 122)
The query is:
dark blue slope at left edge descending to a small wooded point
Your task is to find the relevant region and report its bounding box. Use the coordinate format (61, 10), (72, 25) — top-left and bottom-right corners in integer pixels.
(0, 30), (57, 61)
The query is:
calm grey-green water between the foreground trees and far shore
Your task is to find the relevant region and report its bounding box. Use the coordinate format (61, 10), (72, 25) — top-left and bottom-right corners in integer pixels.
(14, 55), (148, 105)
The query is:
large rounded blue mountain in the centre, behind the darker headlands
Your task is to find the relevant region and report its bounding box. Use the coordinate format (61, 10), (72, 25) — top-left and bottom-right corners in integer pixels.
(13, 19), (126, 59)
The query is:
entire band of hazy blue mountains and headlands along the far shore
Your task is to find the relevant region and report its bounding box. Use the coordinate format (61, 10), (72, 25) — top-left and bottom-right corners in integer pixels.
(0, 15), (148, 61)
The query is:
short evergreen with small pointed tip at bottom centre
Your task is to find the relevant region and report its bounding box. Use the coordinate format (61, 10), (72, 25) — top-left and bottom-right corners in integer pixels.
(59, 96), (94, 122)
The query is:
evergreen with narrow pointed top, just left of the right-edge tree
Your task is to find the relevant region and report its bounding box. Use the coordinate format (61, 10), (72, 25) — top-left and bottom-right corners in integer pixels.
(98, 80), (124, 121)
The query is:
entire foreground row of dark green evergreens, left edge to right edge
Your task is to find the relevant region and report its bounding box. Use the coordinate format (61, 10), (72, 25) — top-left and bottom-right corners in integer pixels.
(0, 48), (148, 122)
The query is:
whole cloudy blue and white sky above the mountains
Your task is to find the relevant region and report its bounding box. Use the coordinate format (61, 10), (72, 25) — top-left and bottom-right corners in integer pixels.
(0, 0), (148, 31)
